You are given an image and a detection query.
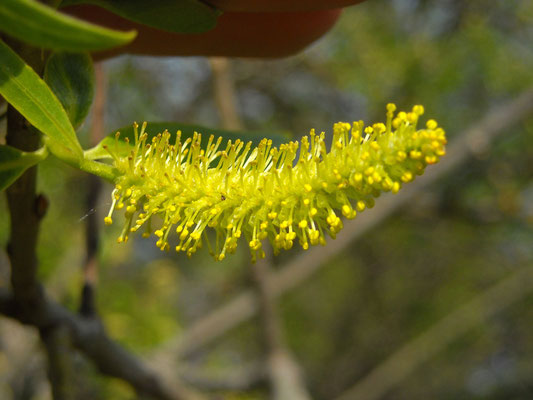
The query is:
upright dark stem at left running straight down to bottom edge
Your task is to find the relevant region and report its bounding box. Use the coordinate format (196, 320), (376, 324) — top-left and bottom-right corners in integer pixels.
(6, 99), (78, 400)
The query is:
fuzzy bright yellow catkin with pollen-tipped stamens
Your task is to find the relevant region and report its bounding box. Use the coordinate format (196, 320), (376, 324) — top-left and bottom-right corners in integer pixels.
(105, 104), (446, 261)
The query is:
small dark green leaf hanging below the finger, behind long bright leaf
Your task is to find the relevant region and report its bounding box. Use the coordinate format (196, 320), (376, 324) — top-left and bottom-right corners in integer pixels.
(44, 53), (94, 128)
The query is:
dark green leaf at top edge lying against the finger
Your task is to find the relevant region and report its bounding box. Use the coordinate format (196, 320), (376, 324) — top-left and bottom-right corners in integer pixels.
(61, 0), (220, 33)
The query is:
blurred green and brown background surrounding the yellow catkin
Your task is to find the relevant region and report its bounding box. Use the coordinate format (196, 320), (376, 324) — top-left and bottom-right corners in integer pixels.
(0, 0), (533, 400)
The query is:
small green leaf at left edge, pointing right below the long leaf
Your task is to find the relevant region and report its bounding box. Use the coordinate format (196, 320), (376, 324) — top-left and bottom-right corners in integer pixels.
(0, 145), (47, 191)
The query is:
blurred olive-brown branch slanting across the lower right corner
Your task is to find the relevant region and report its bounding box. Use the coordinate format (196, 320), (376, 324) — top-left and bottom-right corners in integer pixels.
(337, 265), (533, 400)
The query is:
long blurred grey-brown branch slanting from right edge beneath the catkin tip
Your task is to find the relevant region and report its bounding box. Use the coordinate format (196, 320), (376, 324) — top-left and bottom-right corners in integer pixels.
(149, 89), (533, 357)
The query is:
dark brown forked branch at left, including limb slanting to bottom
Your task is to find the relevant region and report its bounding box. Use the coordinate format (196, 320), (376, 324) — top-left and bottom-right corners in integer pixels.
(0, 52), (205, 400)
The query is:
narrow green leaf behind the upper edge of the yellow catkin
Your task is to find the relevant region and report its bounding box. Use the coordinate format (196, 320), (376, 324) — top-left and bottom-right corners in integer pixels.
(85, 122), (288, 160)
